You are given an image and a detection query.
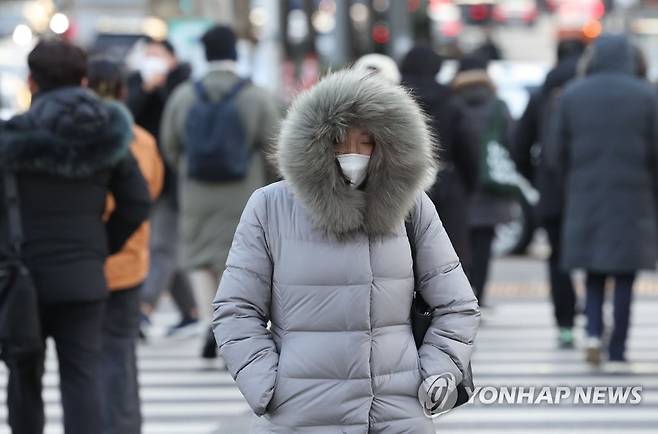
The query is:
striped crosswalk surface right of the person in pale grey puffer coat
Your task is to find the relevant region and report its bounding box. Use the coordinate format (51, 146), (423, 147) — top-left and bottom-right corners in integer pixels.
(435, 296), (658, 434)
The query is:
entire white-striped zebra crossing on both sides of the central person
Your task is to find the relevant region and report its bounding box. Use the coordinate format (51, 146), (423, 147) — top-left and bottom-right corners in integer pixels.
(0, 296), (658, 434)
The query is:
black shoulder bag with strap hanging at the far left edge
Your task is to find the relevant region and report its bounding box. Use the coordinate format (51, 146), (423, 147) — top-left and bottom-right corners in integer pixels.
(0, 170), (43, 362)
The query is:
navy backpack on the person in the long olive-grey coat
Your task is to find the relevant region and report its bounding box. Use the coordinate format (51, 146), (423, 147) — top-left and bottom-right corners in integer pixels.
(184, 80), (251, 182)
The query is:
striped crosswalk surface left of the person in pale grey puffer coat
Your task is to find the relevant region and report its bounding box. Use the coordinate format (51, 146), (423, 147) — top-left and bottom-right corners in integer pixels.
(0, 314), (249, 434)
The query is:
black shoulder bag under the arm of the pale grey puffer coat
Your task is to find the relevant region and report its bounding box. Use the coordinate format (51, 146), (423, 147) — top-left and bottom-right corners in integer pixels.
(404, 218), (475, 408)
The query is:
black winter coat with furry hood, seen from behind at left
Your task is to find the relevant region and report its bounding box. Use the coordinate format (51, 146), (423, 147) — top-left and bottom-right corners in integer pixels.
(0, 87), (150, 303)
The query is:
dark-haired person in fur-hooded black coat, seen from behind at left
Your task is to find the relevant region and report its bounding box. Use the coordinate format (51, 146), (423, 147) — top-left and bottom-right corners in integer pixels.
(0, 40), (151, 434)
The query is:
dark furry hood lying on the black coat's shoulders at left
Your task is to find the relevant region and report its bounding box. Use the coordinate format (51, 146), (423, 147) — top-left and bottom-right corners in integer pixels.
(0, 87), (132, 178)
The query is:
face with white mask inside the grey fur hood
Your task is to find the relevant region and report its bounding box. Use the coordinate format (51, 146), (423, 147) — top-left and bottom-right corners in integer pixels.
(336, 128), (374, 188)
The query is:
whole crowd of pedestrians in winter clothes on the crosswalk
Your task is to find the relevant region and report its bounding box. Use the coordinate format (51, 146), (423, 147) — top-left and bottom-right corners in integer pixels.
(0, 22), (658, 434)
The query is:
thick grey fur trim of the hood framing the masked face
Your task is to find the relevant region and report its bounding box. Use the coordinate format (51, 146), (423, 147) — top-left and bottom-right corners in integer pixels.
(274, 69), (437, 238)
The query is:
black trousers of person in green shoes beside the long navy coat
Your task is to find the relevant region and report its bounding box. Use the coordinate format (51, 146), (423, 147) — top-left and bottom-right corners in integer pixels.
(543, 217), (576, 327)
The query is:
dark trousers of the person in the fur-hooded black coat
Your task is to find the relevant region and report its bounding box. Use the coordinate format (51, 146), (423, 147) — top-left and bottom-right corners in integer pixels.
(7, 301), (105, 434)
